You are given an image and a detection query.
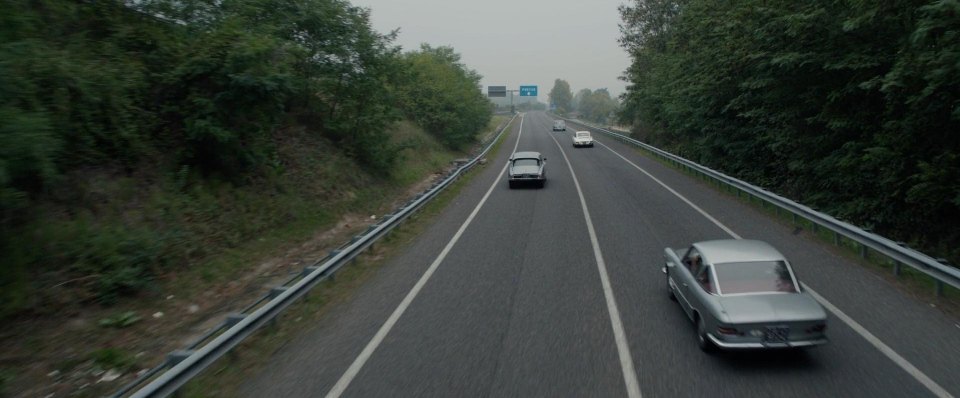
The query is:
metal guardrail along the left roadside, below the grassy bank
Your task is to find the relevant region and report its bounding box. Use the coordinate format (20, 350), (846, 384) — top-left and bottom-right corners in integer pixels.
(113, 115), (516, 397)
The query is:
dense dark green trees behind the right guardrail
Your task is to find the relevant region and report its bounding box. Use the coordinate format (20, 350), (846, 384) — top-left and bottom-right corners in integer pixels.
(619, 0), (960, 264)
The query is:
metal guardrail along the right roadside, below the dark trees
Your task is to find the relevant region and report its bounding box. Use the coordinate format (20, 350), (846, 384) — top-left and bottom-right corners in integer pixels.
(558, 116), (960, 296)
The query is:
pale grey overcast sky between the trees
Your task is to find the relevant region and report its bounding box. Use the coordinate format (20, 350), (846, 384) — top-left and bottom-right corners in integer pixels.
(350, 0), (630, 102)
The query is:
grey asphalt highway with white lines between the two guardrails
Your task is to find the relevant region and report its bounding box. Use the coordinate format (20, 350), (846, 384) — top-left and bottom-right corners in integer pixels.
(241, 112), (960, 397)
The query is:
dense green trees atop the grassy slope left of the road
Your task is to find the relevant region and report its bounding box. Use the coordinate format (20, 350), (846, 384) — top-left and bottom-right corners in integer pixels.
(0, 0), (492, 314)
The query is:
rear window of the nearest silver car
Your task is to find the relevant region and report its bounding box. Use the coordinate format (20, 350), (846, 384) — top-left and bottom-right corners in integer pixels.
(714, 261), (797, 294)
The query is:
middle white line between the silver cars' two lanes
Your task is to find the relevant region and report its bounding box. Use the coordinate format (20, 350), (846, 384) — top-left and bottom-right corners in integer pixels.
(550, 135), (641, 398)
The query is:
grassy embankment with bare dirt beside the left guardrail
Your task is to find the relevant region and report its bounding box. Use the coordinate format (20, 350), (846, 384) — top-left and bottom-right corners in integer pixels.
(0, 117), (505, 396)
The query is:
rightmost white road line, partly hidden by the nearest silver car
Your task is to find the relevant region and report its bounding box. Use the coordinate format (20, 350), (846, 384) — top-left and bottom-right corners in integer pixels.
(598, 135), (953, 398)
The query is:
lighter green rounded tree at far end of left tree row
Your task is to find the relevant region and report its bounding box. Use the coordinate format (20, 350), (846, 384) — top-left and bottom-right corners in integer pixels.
(396, 44), (493, 148)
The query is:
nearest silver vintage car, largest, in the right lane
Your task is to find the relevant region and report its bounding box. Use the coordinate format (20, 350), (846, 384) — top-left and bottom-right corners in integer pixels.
(662, 239), (827, 351)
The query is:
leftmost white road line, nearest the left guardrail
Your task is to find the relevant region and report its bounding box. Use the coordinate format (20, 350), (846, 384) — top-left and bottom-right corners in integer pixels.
(326, 115), (523, 398)
